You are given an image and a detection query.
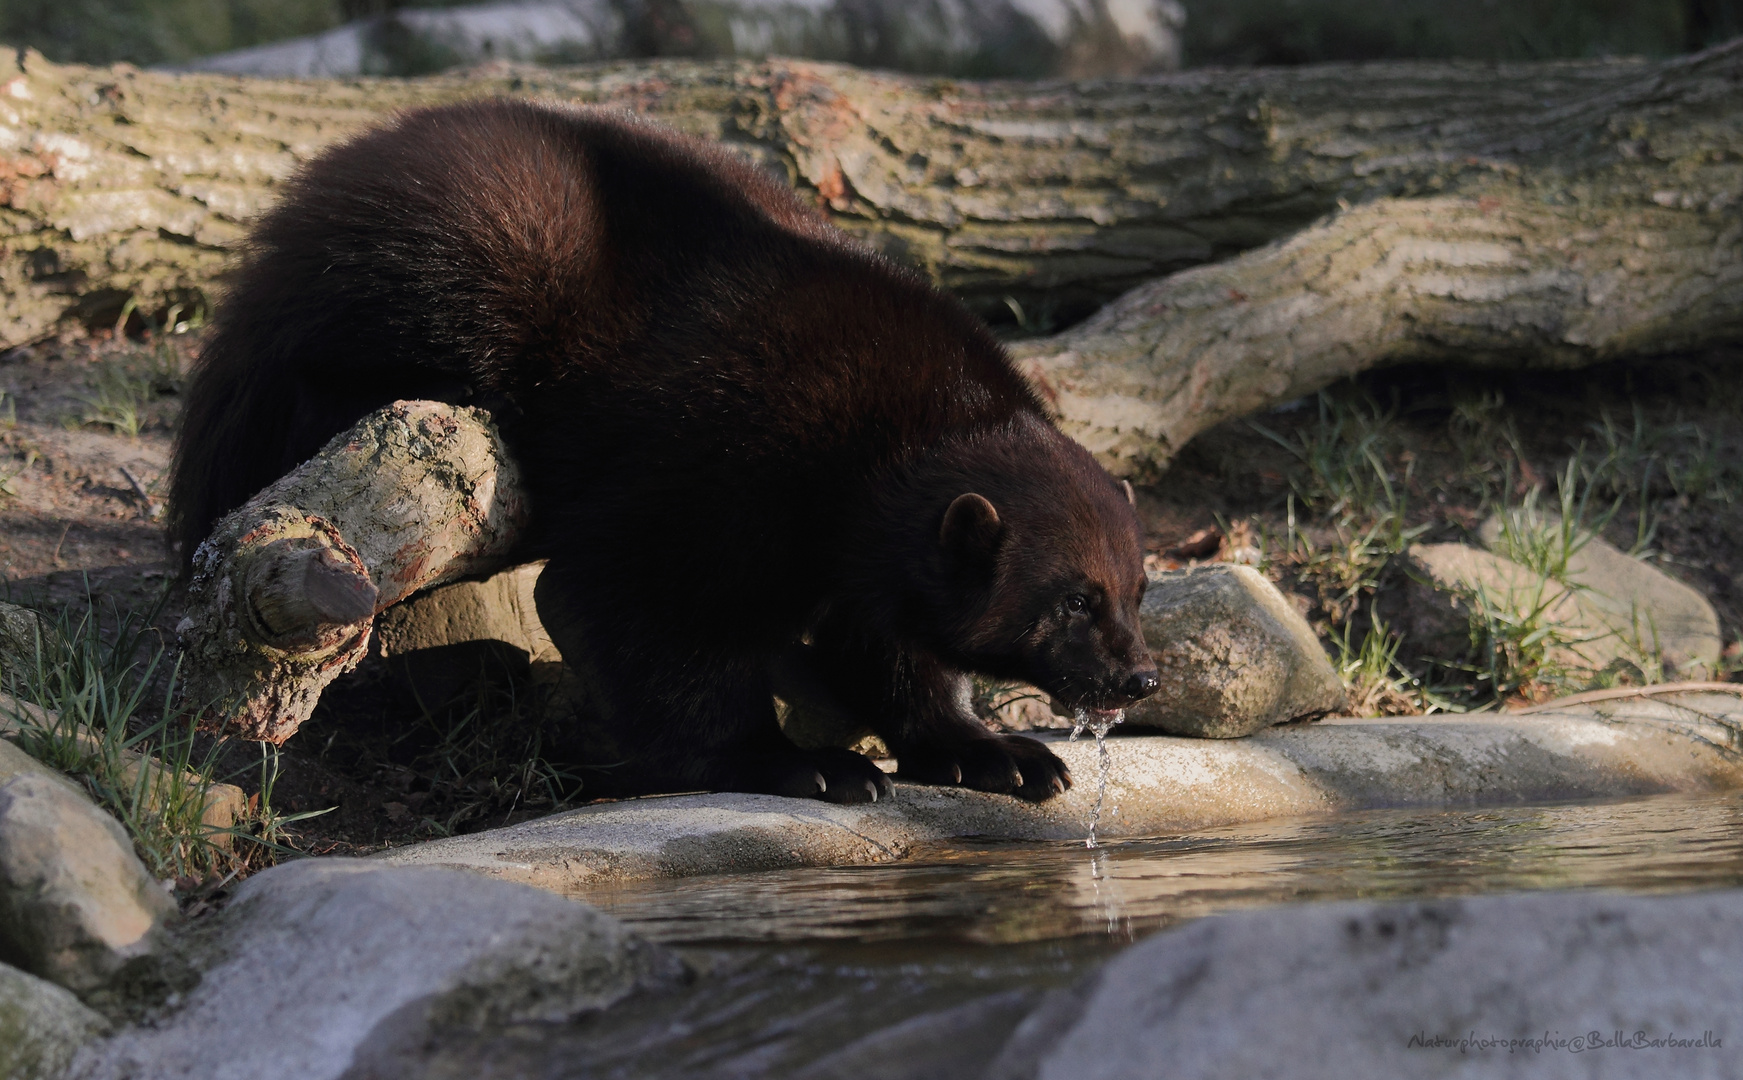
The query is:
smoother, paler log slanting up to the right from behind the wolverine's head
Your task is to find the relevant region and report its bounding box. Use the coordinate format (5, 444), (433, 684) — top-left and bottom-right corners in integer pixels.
(1016, 42), (1743, 477)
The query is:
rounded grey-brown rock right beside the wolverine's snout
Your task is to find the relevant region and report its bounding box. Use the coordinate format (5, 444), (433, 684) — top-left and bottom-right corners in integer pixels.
(1126, 563), (1344, 739)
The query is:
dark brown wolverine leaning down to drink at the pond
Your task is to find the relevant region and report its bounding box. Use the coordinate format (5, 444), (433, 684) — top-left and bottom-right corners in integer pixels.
(173, 103), (1154, 801)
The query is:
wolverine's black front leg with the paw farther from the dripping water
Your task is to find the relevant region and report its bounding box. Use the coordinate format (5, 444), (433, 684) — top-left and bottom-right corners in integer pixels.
(535, 559), (891, 803)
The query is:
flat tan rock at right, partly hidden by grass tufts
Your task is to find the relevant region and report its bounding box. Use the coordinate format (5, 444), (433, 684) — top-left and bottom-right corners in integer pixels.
(1394, 526), (1720, 679)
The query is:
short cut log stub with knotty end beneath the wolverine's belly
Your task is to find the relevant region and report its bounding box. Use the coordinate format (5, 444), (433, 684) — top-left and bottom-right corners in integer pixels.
(176, 401), (526, 744)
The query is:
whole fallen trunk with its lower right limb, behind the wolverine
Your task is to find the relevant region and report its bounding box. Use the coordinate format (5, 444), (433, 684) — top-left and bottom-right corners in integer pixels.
(0, 44), (1743, 452)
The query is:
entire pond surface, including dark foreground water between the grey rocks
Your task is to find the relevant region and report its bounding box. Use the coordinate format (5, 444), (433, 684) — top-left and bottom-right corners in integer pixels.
(407, 793), (1743, 1078)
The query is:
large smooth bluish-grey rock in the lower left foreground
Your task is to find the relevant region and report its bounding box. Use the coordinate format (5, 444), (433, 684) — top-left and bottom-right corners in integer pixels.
(75, 859), (688, 1080)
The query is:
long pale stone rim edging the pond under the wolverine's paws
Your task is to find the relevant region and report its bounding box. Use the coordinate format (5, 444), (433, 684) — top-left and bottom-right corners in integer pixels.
(378, 688), (1743, 890)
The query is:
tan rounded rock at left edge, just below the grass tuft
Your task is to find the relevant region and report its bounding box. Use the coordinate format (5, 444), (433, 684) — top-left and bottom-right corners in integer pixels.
(0, 775), (176, 996)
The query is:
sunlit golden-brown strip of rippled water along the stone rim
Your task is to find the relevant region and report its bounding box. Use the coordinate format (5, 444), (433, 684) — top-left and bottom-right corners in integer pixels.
(579, 794), (1743, 944)
